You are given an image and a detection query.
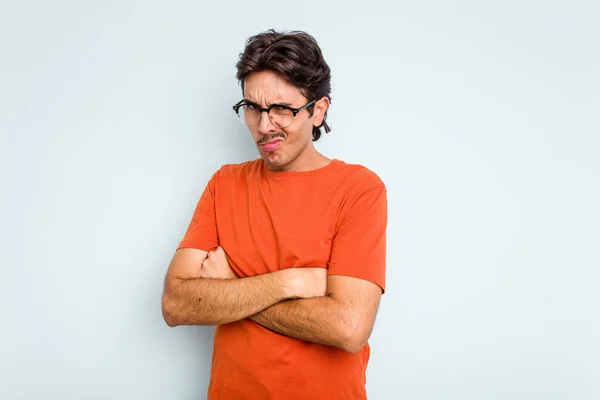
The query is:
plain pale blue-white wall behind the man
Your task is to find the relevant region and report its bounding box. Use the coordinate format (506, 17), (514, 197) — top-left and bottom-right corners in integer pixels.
(0, 0), (600, 400)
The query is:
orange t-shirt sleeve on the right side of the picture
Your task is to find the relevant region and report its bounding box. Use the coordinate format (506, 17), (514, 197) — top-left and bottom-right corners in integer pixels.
(329, 184), (387, 291)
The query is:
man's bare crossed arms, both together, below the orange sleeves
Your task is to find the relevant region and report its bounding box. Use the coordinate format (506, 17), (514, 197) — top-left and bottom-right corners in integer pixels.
(162, 247), (381, 353)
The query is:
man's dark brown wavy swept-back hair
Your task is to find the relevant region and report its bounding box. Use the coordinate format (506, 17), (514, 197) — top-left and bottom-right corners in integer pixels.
(236, 29), (331, 141)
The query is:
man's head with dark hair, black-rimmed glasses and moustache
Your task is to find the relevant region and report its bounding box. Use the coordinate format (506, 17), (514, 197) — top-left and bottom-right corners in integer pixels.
(237, 30), (331, 169)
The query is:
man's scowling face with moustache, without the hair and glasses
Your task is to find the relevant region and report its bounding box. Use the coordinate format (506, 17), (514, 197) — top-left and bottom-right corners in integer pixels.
(244, 71), (315, 170)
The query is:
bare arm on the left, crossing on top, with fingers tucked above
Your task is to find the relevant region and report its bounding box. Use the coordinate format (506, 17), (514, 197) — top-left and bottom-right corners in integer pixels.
(162, 249), (326, 326)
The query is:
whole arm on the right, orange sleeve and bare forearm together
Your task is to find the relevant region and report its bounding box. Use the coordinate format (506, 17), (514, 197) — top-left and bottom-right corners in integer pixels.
(252, 184), (387, 353)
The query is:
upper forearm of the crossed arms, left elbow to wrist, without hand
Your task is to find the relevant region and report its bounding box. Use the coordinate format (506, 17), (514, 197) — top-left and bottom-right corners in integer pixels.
(163, 273), (293, 326)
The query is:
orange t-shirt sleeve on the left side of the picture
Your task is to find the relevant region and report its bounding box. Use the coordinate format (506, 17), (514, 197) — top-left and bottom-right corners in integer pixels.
(177, 174), (219, 251)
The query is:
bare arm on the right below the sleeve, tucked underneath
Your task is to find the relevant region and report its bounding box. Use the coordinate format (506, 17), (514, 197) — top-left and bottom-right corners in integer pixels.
(251, 275), (381, 353)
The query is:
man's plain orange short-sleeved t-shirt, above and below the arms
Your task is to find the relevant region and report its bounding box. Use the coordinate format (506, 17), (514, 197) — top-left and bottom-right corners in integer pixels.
(178, 159), (387, 400)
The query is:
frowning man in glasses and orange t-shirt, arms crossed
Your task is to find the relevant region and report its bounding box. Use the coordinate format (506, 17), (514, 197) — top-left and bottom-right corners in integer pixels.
(162, 30), (387, 400)
